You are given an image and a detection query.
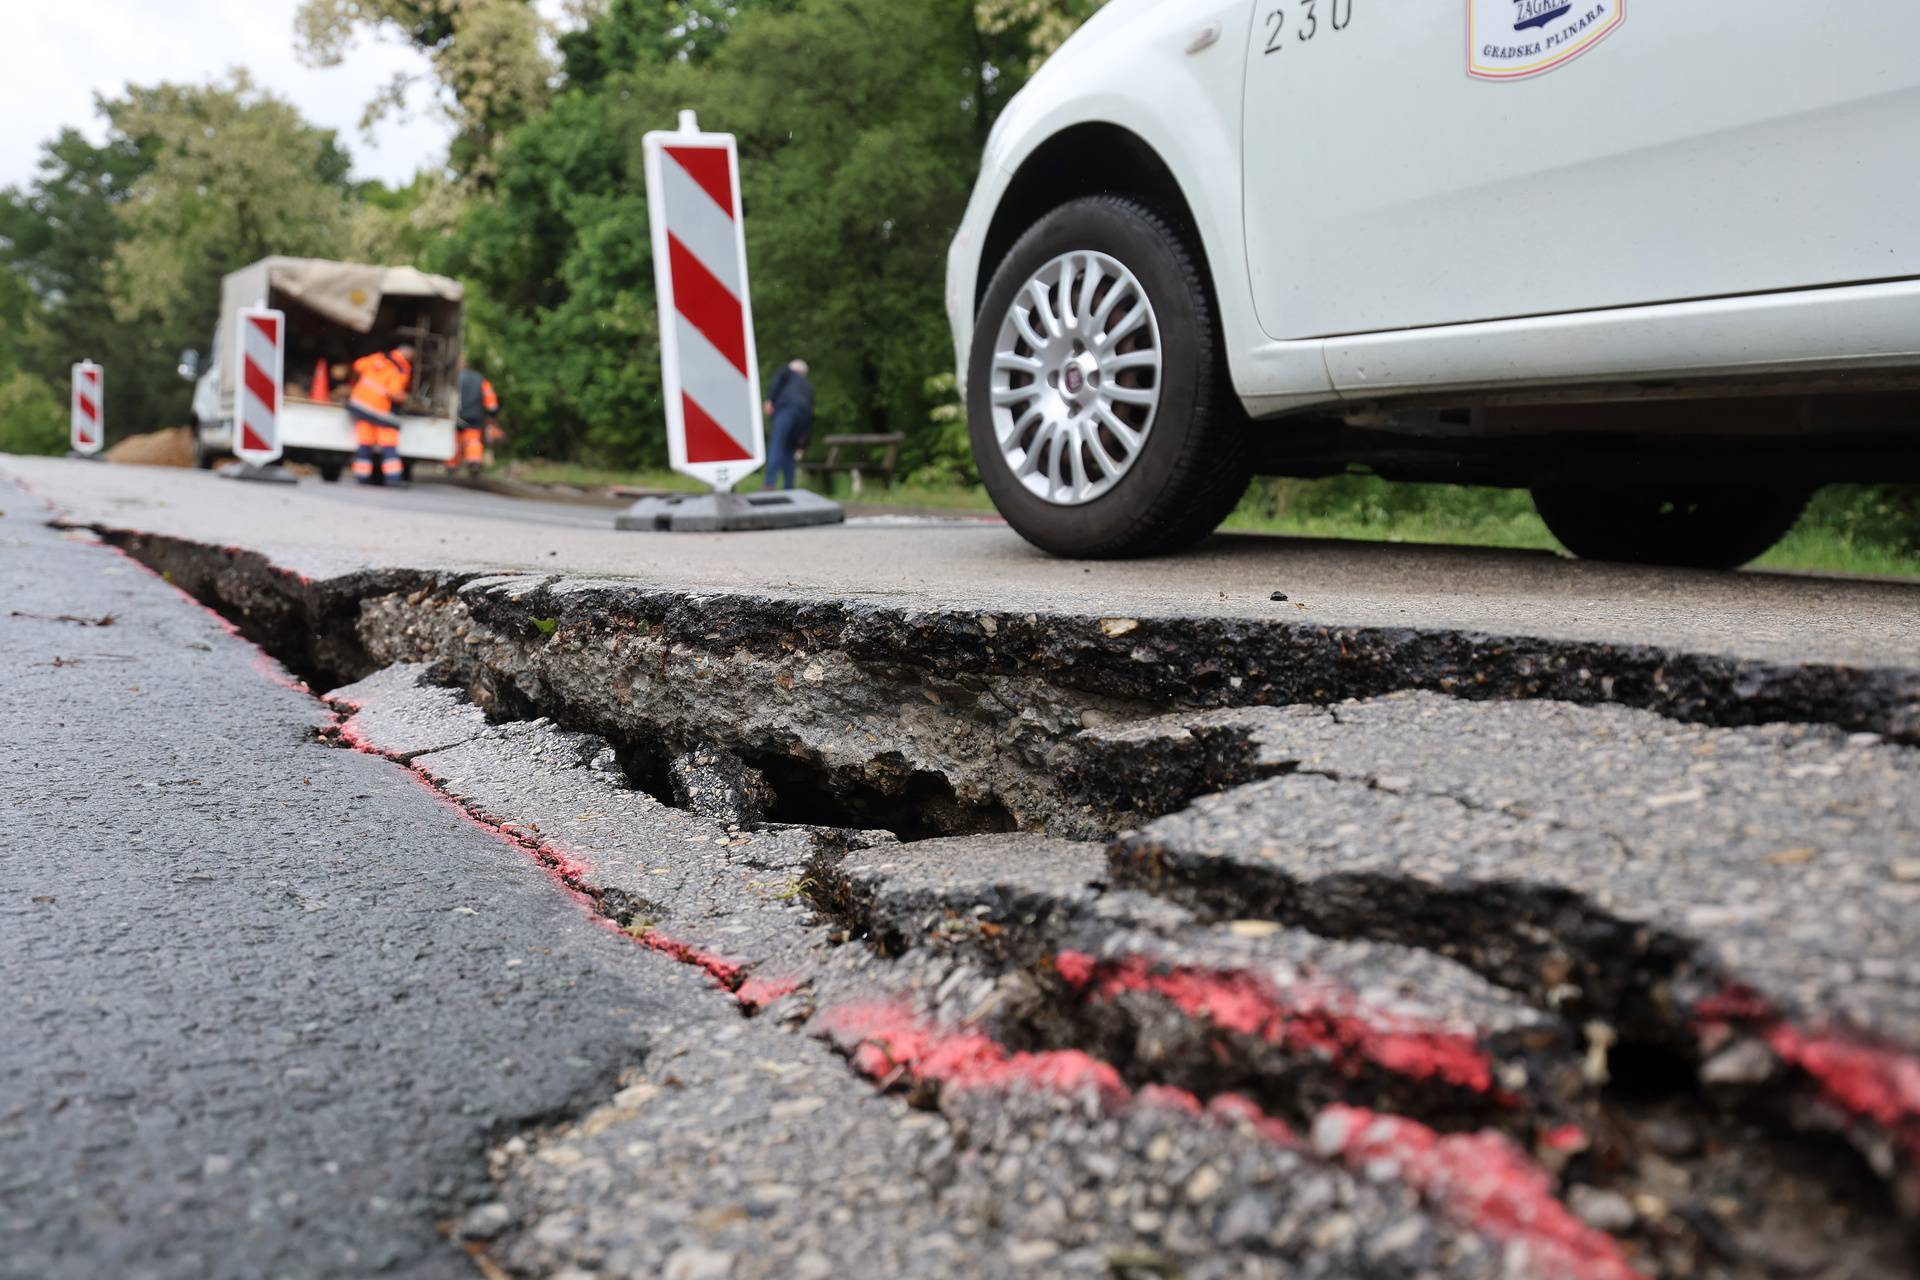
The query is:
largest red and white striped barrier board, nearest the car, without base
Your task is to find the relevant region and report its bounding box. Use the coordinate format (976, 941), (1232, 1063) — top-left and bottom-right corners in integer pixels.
(643, 111), (766, 489)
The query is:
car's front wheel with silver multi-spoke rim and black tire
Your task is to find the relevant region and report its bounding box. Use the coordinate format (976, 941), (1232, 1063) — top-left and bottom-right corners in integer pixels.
(968, 196), (1252, 558)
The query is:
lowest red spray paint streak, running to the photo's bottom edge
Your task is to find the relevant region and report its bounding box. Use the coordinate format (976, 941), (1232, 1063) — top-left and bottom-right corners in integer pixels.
(1313, 1105), (1642, 1280)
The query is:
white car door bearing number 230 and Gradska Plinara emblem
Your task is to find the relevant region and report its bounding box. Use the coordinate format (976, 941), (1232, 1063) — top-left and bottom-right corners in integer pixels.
(1242, 0), (1920, 338)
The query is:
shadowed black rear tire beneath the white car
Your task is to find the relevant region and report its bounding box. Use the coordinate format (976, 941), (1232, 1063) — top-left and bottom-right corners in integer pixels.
(1534, 486), (1812, 568)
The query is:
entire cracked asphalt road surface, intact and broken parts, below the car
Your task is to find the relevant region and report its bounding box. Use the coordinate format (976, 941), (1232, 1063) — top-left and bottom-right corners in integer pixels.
(0, 461), (1920, 1280)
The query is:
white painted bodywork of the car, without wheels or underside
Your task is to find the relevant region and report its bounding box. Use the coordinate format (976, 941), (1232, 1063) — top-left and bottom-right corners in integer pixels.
(948, 0), (1920, 415)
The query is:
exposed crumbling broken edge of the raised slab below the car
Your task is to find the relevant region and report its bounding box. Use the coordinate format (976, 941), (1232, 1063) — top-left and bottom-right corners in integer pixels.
(96, 530), (1920, 837)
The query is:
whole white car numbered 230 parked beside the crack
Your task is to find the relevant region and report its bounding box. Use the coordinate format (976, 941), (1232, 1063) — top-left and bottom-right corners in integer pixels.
(947, 0), (1920, 566)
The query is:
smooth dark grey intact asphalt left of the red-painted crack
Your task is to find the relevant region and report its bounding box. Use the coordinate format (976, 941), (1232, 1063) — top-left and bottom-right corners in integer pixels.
(0, 489), (707, 1278)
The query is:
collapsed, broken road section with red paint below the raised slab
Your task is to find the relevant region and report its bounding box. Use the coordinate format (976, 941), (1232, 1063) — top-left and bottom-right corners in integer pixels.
(71, 521), (1920, 1280)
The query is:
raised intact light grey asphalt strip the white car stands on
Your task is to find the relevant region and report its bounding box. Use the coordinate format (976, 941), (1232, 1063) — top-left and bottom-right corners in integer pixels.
(0, 457), (1920, 668)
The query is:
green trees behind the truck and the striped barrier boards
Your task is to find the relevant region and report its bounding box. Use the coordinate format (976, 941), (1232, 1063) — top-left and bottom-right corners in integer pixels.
(0, 0), (1100, 460)
